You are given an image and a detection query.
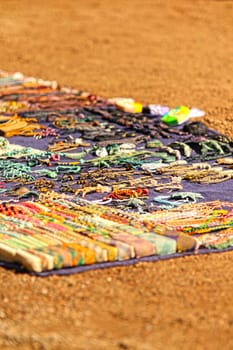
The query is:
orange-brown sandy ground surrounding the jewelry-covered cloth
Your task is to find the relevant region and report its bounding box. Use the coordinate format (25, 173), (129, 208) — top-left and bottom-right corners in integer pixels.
(0, 0), (233, 350)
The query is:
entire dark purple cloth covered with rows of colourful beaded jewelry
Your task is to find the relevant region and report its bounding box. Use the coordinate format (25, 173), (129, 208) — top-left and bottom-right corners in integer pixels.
(0, 71), (233, 272)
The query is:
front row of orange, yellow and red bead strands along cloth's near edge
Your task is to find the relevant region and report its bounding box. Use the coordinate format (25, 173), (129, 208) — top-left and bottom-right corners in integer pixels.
(0, 192), (233, 272)
